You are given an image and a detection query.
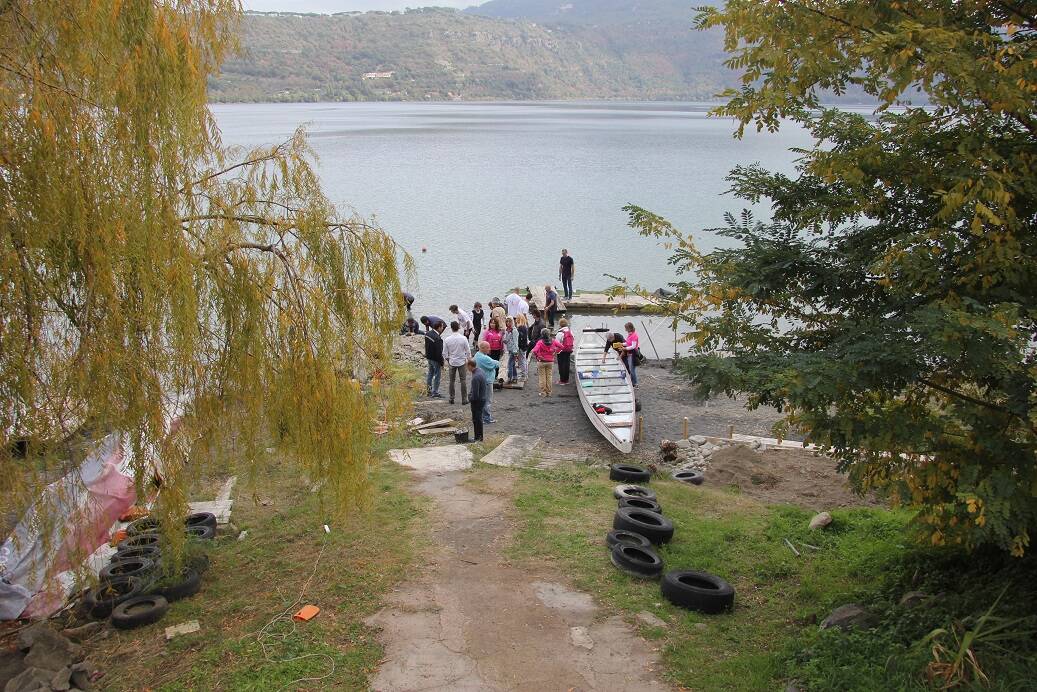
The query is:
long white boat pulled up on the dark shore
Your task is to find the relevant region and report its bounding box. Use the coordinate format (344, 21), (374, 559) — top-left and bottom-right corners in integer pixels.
(574, 330), (637, 454)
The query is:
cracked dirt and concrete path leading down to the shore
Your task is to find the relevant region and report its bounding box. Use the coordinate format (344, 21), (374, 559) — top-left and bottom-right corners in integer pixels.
(368, 460), (669, 692)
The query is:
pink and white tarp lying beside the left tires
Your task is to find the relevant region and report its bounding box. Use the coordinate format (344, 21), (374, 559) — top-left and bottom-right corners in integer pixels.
(0, 434), (137, 619)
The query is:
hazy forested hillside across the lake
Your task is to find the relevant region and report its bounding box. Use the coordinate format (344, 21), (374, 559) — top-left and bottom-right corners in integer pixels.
(209, 5), (733, 102)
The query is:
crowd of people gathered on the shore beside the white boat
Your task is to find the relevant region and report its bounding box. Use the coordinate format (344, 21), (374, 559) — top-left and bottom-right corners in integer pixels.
(401, 250), (640, 441)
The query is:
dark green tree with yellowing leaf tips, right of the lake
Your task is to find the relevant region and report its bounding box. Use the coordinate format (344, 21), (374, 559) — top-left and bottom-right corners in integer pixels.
(628, 0), (1037, 555)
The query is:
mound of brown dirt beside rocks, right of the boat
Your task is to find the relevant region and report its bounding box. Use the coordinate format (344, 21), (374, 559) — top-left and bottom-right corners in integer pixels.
(706, 445), (879, 509)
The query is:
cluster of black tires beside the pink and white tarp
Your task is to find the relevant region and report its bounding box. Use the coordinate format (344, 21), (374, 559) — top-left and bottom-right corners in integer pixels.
(83, 511), (216, 630)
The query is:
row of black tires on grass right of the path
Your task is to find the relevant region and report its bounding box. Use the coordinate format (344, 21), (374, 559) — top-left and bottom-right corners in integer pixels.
(606, 464), (734, 613)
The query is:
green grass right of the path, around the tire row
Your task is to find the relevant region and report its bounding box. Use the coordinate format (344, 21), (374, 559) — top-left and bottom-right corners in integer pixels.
(497, 468), (1034, 690)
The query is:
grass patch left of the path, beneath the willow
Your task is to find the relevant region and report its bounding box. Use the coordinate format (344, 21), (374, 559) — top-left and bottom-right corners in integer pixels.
(89, 441), (424, 690)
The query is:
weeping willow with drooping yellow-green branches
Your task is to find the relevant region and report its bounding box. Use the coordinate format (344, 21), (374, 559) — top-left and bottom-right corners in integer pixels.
(0, 0), (410, 593)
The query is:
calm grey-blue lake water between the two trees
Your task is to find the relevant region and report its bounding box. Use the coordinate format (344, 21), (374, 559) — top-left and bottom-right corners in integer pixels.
(213, 98), (811, 351)
